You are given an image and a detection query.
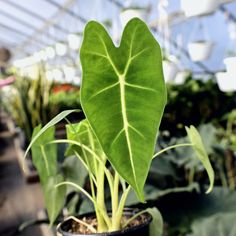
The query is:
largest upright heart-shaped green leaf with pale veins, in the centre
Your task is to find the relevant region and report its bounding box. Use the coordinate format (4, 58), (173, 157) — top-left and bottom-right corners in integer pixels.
(80, 18), (166, 201)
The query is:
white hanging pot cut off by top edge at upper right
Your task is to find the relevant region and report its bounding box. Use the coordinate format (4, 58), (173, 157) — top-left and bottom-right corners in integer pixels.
(181, 0), (219, 17)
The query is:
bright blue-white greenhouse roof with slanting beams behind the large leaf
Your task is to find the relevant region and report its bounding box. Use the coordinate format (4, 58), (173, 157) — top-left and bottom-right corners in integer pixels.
(0, 0), (236, 74)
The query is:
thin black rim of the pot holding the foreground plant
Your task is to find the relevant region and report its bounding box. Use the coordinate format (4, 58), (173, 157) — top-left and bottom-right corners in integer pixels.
(57, 208), (152, 236)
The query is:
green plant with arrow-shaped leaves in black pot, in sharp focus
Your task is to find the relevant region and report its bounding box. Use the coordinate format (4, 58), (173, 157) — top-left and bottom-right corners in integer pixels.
(25, 18), (214, 236)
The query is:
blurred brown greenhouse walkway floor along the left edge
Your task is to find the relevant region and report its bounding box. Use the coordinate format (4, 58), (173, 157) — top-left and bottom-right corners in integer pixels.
(0, 113), (43, 236)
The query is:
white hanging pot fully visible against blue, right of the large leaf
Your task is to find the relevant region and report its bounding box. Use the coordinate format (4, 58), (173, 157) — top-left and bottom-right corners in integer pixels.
(188, 41), (213, 61)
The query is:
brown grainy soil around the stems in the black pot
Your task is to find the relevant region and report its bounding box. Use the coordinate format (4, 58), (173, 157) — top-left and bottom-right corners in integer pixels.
(69, 214), (148, 234)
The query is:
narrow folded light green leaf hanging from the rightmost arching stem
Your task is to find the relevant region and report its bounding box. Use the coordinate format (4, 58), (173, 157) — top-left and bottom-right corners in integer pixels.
(185, 125), (214, 193)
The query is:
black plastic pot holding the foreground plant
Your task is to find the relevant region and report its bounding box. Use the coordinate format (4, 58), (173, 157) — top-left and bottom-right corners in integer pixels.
(57, 209), (152, 236)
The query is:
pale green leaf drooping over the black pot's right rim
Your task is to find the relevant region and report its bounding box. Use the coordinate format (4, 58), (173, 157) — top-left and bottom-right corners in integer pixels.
(147, 207), (163, 236)
